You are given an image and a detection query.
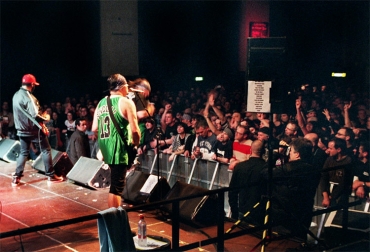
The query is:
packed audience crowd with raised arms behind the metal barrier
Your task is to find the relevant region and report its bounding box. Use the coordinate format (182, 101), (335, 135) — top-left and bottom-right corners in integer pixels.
(0, 80), (370, 236)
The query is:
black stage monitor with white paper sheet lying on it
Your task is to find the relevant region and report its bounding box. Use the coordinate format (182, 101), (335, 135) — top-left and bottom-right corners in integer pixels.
(122, 170), (171, 204)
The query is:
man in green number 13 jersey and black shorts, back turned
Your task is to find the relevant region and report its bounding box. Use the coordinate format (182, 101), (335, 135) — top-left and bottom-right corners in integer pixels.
(92, 74), (140, 207)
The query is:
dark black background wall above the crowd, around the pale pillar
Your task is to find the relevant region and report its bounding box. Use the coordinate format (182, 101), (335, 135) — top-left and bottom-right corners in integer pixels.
(0, 1), (370, 106)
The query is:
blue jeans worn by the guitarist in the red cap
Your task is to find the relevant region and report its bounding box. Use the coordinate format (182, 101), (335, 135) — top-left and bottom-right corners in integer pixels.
(15, 135), (54, 176)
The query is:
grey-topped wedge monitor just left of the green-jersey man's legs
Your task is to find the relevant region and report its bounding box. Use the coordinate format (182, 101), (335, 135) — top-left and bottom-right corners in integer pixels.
(67, 157), (111, 189)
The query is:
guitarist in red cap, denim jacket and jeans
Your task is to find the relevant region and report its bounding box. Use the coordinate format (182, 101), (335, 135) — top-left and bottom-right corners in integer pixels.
(12, 74), (63, 186)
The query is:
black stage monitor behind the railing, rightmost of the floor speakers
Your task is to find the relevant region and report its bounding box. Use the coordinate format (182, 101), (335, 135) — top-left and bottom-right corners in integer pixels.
(163, 181), (217, 226)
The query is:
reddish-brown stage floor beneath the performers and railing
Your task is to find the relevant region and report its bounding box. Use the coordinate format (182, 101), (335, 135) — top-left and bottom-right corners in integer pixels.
(0, 161), (368, 251)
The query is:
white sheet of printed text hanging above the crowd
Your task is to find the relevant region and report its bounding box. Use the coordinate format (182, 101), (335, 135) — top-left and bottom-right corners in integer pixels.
(247, 81), (271, 113)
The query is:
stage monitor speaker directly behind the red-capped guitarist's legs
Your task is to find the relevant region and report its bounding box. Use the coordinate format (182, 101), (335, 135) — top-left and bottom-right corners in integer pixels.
(32, 149), (73, 177)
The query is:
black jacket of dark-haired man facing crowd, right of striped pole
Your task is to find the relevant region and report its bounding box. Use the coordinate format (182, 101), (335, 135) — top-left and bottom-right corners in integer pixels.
(264, 160), (320, 238)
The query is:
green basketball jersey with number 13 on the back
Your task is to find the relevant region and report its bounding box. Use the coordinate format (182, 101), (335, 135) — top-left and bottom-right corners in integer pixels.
(97, 96), (132, 165)
